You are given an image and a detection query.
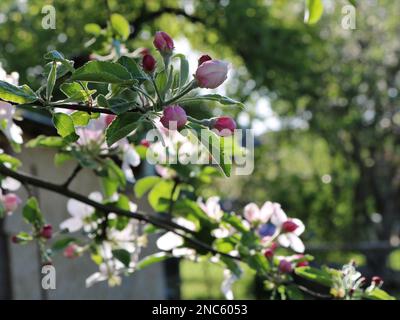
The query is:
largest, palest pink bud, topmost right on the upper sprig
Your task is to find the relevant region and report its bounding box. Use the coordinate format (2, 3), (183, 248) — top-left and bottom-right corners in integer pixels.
(195, 60), (228, 89)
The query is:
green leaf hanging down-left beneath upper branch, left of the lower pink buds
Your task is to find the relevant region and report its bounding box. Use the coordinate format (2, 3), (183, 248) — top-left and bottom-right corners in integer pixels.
(106, 112), (141, 147)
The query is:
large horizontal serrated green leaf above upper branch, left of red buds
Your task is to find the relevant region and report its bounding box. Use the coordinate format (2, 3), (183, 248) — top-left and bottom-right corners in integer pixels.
(71, 61), (132, 83)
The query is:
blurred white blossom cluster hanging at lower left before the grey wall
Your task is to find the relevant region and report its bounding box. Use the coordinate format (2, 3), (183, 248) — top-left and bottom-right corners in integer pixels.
(60, 191), (146, 287)
